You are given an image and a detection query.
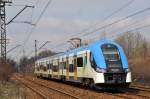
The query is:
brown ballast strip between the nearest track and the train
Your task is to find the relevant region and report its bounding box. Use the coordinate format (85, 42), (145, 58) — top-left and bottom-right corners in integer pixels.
(13, 75), (123, 99)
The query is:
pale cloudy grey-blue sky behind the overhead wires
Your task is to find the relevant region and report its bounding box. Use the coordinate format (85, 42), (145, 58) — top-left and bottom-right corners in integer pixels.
(6, 0), (150, 60)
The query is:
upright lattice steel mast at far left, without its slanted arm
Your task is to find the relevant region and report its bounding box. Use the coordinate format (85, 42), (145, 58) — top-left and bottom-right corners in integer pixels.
(0, 0), (12, 63)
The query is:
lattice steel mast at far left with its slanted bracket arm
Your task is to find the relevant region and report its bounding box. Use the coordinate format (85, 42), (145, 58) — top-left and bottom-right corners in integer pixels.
(0, 0), (34, 63)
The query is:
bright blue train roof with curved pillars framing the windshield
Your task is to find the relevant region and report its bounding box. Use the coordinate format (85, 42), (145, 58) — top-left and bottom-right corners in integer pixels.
(38, 39), (128, 68)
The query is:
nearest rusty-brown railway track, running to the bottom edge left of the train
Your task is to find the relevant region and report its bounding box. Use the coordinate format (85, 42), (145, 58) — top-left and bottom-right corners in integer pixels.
(15, 76), (81, 99)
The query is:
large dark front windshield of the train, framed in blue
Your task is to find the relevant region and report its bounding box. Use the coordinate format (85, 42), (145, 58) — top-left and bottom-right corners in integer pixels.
(101, 44), (122, 67)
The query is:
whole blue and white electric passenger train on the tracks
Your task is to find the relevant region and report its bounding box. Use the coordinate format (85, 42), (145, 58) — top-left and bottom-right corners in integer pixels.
(34, 39), (132, 88)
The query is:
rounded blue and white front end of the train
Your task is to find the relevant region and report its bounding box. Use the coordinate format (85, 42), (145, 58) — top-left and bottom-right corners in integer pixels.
(91, 40), (131, 87)
